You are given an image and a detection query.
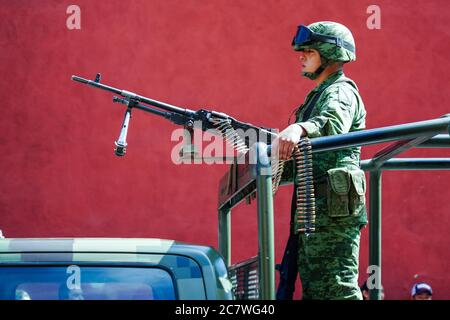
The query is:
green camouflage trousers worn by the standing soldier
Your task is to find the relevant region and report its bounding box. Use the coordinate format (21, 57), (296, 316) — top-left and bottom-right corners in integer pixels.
(297, 225), (362, 300)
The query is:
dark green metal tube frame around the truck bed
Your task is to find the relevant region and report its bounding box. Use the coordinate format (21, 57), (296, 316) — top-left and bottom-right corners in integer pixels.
(219, 114), (450, 300)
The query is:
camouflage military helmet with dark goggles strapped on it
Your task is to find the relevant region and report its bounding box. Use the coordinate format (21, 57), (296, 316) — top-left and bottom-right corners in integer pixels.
(292, 21), (356, 62)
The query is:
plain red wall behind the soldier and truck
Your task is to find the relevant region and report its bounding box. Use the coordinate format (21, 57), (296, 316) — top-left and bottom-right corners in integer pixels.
(0, 0), (450, 299)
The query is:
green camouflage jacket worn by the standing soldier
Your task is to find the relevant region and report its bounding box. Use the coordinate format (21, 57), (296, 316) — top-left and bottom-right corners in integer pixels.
(296, 71), (367, 227)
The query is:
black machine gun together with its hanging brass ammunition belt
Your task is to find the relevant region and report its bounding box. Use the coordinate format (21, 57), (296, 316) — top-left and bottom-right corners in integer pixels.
(72, 73), (315, 226)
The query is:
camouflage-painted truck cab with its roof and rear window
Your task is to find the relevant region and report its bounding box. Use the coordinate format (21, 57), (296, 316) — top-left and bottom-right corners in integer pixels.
(0, 238), (234, 300)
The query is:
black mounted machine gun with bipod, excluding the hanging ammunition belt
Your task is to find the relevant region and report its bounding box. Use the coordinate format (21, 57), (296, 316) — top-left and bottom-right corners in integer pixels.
(72, 73), (276, 156)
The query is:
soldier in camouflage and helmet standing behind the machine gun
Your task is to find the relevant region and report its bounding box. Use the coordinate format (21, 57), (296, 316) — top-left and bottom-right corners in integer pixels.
(274, 21), (367, 300)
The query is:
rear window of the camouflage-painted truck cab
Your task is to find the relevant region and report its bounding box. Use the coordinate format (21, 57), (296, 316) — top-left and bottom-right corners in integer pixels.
(0, 266), (176, 300)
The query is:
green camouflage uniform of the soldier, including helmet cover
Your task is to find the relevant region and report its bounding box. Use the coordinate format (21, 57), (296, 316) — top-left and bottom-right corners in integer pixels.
(291, 22), (367, 300)
